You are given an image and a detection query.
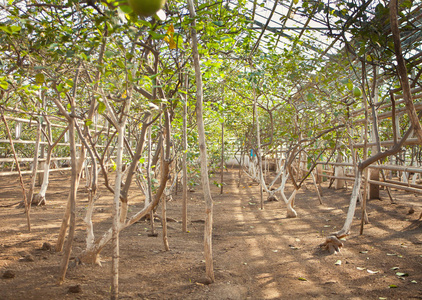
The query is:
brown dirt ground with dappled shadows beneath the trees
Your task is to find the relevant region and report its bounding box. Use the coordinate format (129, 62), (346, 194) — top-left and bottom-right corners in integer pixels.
(0, 170), (422, 300)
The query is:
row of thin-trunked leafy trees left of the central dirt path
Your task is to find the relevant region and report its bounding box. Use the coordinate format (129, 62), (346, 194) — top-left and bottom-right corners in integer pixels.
(1, 1), (258, 298)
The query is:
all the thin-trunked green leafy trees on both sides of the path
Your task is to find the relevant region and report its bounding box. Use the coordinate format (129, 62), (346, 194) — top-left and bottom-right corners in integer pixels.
(0, 0), (421, 298)
